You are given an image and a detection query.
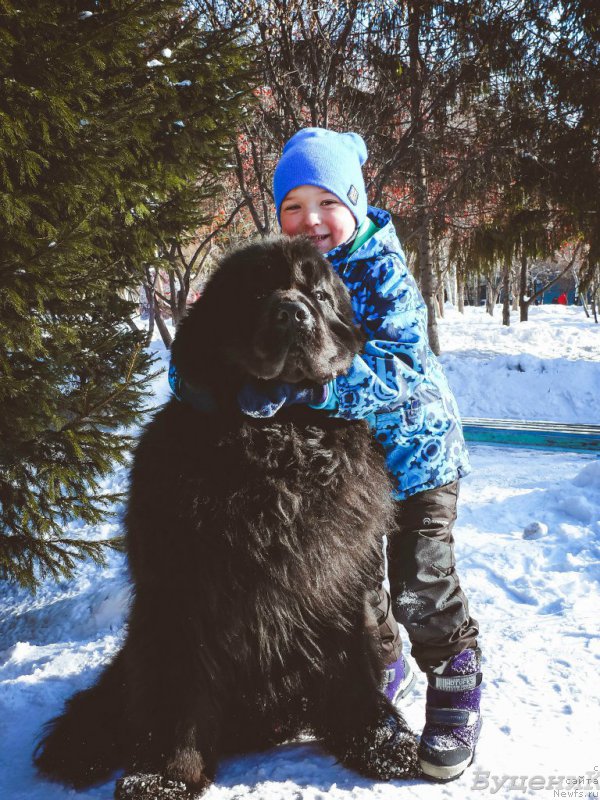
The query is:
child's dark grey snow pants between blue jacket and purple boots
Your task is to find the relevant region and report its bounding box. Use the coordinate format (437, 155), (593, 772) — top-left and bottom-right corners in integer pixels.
(366, 481), (479, 671)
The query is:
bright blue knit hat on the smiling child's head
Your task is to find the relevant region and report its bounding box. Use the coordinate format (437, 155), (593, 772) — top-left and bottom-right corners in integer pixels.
(273, 128), (367, 225)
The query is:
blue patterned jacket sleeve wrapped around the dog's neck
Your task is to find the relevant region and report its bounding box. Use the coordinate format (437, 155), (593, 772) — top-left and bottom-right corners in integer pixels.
(313, 253), (429, 419)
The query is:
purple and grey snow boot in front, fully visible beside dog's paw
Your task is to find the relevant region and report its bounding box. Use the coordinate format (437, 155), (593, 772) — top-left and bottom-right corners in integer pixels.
(419, 649), (481, 781)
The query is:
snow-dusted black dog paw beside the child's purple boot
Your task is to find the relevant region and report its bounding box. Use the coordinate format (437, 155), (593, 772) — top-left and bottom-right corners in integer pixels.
(342, 714), (421, 781)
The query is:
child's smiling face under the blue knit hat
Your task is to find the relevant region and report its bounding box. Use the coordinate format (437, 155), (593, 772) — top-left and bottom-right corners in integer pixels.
(279, 185), (356, 253)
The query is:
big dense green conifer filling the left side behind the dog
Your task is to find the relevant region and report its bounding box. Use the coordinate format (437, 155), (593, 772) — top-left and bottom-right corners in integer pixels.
(0, 0), (249, 587)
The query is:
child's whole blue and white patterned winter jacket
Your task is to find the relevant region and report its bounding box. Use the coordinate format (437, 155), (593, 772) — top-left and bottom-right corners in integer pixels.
(315, 207), (470, 499)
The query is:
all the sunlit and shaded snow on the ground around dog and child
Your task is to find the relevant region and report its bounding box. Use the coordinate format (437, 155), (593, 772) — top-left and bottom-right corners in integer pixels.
(0, 306), (600, 800)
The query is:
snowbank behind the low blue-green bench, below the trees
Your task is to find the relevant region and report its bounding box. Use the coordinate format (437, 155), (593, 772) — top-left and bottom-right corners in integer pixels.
(440, 305), (600, 424)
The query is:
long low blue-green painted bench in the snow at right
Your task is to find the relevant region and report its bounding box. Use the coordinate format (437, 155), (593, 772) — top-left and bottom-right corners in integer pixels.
(462, 417), (600, 453)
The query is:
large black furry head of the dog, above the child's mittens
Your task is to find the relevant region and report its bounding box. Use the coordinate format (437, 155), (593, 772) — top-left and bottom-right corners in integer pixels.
(172, 236), (363, 386)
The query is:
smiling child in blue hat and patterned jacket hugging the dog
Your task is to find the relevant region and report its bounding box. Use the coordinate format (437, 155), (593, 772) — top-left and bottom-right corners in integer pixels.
(264, 128), (481, 781)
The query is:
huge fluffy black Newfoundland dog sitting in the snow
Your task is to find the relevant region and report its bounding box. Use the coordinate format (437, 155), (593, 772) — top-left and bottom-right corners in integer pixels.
(36, 237), (417, 800)
